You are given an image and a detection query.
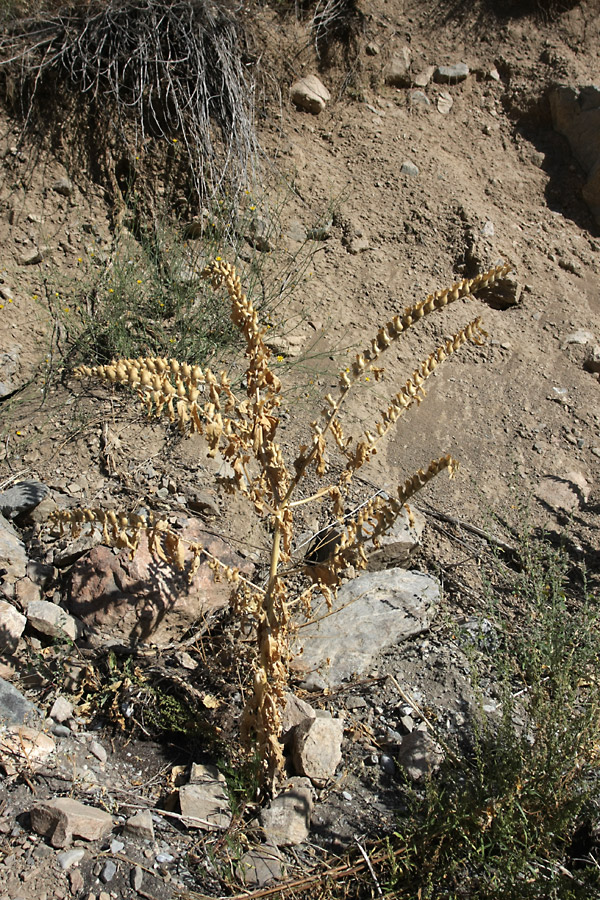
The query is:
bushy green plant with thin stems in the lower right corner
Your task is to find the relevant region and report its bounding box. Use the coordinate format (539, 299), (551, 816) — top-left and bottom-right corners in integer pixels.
(390, 535), (600, 900)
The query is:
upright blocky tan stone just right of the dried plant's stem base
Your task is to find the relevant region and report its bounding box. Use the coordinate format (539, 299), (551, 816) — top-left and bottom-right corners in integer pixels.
(292, 716), (344, 787)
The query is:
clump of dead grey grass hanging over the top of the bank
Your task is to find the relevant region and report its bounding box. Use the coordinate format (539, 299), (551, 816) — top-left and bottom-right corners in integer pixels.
(0, 0), (257, 209)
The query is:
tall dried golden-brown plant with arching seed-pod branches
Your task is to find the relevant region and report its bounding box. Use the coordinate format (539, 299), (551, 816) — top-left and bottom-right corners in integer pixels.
(54, 260), (511, 790)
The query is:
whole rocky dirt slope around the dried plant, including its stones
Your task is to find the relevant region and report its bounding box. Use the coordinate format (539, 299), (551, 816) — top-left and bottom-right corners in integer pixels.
(0, 2), (600, 900)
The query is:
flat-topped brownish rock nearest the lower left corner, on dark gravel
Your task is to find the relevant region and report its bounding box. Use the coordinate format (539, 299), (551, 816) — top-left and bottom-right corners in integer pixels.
(29, 797), (113, 847)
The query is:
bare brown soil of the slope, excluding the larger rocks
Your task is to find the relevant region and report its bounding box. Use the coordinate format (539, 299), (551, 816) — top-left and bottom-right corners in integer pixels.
(0, 2), (600, 900)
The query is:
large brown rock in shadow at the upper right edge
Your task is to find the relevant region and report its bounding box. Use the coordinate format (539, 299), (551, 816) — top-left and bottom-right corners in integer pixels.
(550, 85), (600, 224)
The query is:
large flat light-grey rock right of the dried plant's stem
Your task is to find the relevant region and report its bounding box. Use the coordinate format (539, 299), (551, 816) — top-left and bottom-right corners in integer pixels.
(292, 569), (440, 686)
